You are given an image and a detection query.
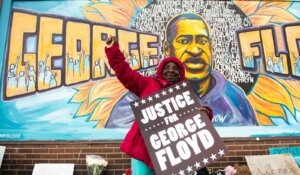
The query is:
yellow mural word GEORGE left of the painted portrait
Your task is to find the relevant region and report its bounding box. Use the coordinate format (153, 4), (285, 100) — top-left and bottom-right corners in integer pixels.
(4, 10), (159, 99)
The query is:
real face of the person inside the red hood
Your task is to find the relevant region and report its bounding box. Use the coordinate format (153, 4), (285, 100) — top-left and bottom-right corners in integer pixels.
(163, 62), (180, 83)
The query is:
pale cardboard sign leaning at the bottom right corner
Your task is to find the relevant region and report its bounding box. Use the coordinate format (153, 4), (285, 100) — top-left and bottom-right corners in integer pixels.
(245, 154), (300, 175)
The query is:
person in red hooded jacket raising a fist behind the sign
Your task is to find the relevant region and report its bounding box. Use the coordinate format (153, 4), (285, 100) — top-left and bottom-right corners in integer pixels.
(105, 36), (213, 175)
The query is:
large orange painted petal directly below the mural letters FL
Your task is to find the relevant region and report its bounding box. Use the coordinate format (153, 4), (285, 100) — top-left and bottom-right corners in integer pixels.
(253, 75), (295, 115)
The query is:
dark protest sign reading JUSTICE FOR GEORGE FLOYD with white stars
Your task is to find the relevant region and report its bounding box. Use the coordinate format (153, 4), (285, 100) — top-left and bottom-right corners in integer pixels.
(131, 81), (227, 175)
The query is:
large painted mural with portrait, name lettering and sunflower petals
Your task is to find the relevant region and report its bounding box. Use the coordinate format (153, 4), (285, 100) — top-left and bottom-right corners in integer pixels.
(0, 0), (300, 140)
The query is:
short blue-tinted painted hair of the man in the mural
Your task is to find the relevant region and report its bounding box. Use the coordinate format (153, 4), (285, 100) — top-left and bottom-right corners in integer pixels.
(165, 13), (210, 43)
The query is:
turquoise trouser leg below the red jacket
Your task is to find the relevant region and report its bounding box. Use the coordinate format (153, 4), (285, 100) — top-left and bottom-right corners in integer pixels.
(131, 158), (154, 175)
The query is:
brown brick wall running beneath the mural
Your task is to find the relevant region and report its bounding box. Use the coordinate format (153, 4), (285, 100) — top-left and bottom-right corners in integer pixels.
(0, 137), (300, 175)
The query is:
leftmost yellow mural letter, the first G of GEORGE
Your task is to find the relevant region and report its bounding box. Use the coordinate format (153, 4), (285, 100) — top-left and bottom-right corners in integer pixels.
(5, 12), (37, 97)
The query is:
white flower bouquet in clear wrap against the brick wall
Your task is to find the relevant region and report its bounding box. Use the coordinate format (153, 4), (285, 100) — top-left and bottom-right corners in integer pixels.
(86, 155), (108, 175)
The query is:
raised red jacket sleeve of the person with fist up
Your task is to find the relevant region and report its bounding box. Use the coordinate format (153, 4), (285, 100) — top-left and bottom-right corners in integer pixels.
(105, 44), (146, 97)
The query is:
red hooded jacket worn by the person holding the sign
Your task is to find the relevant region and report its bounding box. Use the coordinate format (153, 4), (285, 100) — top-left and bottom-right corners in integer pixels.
(105, 44), (212, 169)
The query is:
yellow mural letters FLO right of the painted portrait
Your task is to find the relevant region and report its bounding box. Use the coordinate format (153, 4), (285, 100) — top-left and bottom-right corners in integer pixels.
(237, 24), (300, 77)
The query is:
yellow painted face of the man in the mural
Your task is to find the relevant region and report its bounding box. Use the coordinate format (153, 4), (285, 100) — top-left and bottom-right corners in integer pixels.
(170, 19), (212, 80)
